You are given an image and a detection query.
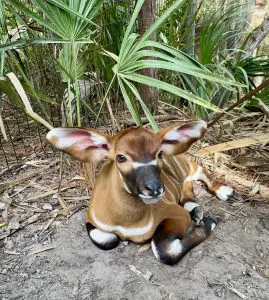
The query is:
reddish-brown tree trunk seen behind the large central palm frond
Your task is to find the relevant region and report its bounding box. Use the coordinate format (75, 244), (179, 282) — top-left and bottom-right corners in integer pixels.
(138, 0), (158, 113)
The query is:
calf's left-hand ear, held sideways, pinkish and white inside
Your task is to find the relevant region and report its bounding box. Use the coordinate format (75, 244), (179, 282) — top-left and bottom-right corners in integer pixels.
(46, 128), (110, 162)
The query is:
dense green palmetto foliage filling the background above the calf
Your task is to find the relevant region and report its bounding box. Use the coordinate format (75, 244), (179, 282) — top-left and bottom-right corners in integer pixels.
(0, 0), (268, 130)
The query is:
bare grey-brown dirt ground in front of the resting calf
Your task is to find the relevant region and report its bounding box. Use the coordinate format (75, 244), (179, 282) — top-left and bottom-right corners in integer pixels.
(0, 177), (269, 300)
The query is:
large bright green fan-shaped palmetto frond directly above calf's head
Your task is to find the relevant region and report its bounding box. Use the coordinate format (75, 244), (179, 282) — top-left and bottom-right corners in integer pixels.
(103, 0), (243, 130)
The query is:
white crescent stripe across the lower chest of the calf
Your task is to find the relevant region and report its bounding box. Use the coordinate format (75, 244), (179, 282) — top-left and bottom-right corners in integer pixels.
(92, 213), (153, 237)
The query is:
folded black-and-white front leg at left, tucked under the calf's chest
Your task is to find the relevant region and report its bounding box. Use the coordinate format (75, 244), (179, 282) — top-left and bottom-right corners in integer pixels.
(86, 222), (120, 250)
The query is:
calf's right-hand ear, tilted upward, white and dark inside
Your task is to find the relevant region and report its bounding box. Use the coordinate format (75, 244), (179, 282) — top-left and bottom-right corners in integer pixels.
(159, 120), (207, 155)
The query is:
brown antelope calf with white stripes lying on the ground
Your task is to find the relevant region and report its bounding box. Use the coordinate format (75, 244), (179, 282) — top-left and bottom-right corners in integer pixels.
(47, 121), (239, 265)
